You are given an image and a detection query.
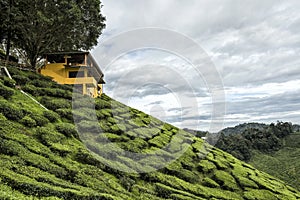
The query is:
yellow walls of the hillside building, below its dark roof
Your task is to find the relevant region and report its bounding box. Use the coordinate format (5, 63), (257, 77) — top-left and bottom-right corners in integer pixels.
(40, 63), (103, 97)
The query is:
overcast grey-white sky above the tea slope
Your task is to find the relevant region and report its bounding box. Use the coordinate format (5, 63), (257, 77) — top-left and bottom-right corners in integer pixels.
(93, 0), (300, 130)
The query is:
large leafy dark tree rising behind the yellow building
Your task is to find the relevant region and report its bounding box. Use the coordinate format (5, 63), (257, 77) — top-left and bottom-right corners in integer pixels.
(1, 0), (105, 67)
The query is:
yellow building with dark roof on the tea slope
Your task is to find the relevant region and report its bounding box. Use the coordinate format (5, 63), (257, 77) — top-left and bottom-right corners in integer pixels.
(38, 51), (105, 97)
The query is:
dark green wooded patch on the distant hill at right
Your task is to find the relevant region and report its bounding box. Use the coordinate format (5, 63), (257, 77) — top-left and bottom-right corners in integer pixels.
(215, 122), (295, 161)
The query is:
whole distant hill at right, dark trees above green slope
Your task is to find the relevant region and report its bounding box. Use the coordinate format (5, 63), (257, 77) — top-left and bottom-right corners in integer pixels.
(211, 122), (300, 189)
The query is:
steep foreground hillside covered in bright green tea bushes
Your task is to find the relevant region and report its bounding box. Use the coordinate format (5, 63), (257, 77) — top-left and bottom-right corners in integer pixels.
(0, 65), (300, 200)
